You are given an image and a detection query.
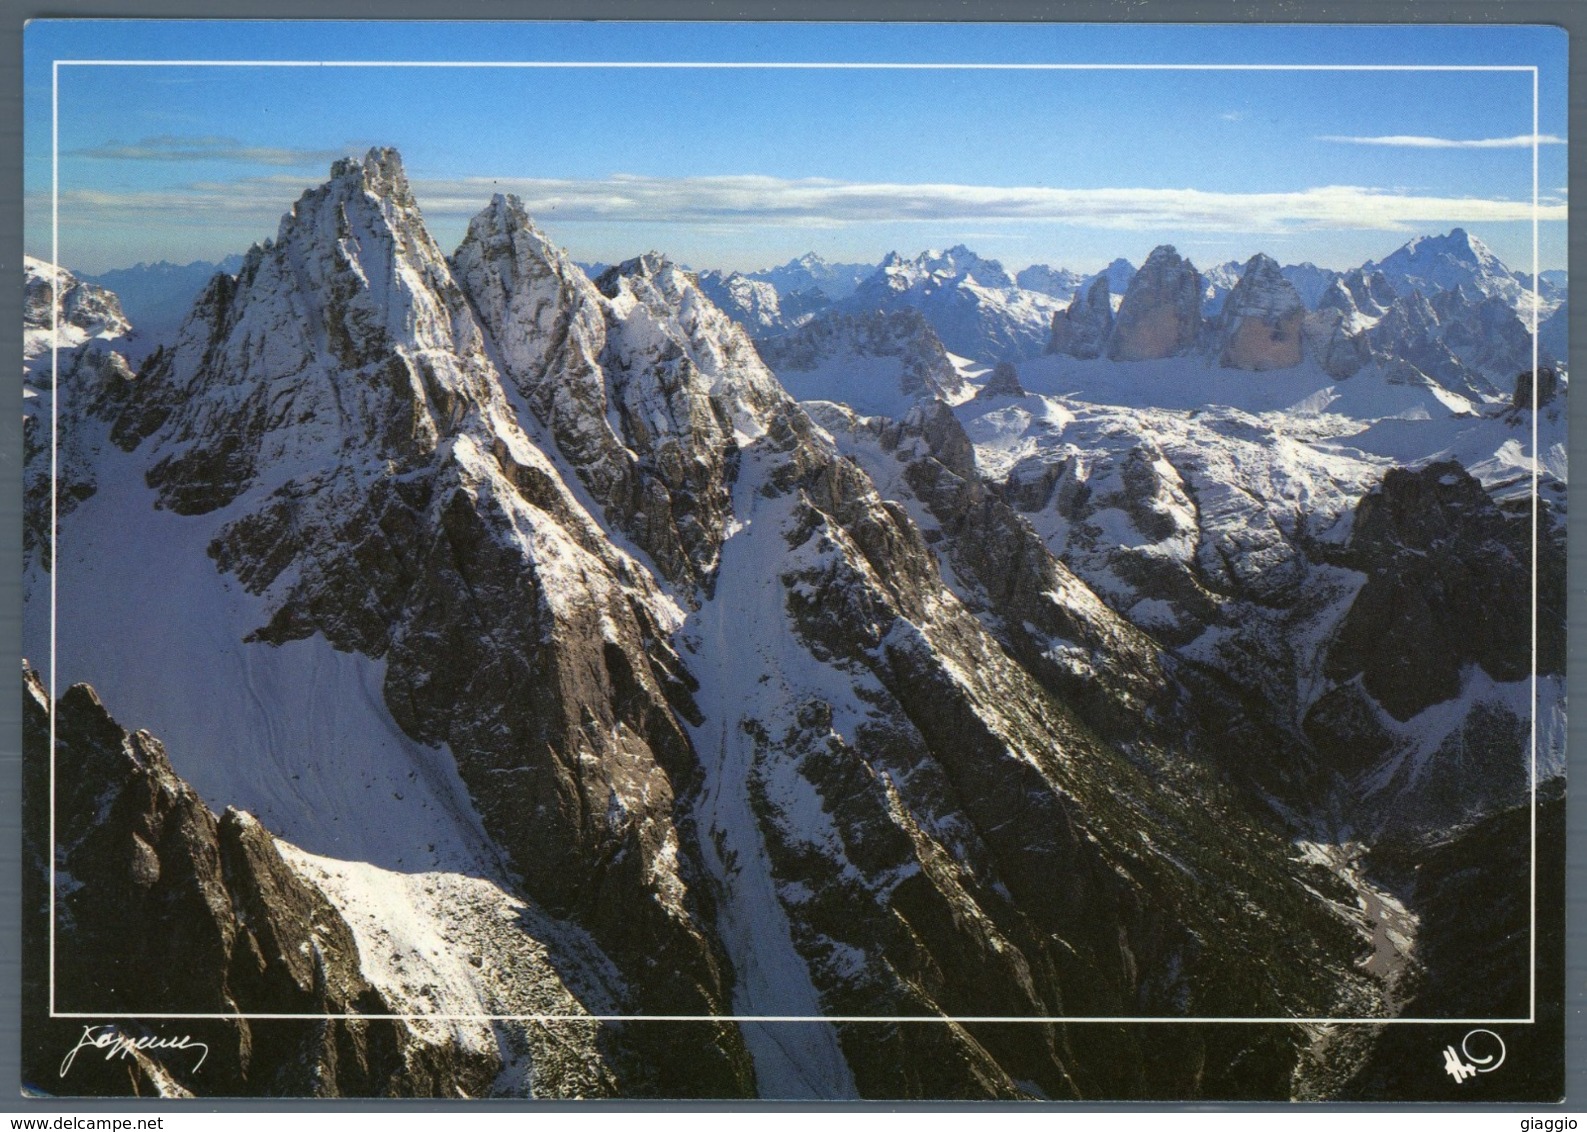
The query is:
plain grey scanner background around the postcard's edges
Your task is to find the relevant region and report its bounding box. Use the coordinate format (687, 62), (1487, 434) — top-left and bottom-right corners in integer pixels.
(0, 0), (1587, 1115)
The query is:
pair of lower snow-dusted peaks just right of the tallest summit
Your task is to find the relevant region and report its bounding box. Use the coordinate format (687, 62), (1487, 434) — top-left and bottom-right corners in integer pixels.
(452, 197), (776, 586)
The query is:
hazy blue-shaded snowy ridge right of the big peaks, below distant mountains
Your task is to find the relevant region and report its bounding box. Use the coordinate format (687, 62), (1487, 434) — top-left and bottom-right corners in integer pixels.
(755, 308), (965, 408)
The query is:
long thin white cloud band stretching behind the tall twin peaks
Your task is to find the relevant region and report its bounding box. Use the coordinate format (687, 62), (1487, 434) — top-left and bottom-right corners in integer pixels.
(43, 175), (1566, 233)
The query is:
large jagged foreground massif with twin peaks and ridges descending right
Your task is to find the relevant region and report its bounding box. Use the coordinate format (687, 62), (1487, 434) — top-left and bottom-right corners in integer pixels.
(27, 151), (1561, 1095)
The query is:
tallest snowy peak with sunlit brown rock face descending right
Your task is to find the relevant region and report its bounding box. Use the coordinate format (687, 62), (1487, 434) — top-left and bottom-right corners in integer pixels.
(100, 151), (755, 1092)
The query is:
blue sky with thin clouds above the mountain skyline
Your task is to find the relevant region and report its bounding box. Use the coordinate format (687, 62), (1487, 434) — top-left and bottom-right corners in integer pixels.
(24, 21), (1566, 271)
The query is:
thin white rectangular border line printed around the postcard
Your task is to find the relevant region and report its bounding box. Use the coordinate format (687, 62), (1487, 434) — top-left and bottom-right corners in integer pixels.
(49, 50), (1541, 1026)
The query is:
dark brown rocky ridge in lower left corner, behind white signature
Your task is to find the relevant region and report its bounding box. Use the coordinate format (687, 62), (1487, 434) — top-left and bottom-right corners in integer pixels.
(22, 668), (500, 1097)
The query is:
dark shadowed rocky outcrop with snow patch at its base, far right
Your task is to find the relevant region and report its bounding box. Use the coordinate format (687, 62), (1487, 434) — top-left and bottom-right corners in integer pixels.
(1305, 460), (1565, 840)
